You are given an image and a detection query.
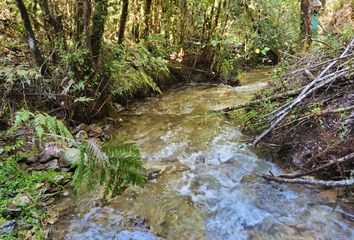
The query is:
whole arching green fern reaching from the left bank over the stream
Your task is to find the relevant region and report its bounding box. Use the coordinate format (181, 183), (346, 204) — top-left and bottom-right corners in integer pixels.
(10, 110), (145, 197)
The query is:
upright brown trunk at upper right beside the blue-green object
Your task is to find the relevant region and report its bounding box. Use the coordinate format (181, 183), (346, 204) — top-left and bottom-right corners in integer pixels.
(301, 0), (312, 51)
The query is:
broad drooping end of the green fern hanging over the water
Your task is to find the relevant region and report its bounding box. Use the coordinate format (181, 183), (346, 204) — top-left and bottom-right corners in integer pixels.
(74, 141), (145, 197)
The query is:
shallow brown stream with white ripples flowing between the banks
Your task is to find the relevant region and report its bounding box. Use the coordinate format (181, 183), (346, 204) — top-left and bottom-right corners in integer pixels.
(51, 67), (354, 240)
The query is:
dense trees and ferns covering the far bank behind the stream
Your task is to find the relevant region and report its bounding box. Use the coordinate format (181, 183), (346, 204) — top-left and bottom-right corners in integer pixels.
(0, 0), (322, 119)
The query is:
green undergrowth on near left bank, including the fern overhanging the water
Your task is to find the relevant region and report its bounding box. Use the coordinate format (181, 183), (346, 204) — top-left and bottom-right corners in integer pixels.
(0, 110), (145, 239)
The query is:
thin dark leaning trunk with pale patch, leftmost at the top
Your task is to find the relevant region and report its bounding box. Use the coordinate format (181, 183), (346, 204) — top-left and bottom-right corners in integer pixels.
(16, 0), (47, 75)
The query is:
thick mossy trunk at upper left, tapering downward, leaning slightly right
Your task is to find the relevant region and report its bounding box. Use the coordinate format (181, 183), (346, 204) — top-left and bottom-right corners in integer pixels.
(91, 0), (108, 63)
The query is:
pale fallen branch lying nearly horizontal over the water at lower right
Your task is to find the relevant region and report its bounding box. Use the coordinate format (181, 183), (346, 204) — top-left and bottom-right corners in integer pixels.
(263, 175), (354, 187)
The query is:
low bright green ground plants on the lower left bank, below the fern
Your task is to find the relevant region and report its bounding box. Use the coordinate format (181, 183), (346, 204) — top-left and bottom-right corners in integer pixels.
(0, 154), (68, 239)
